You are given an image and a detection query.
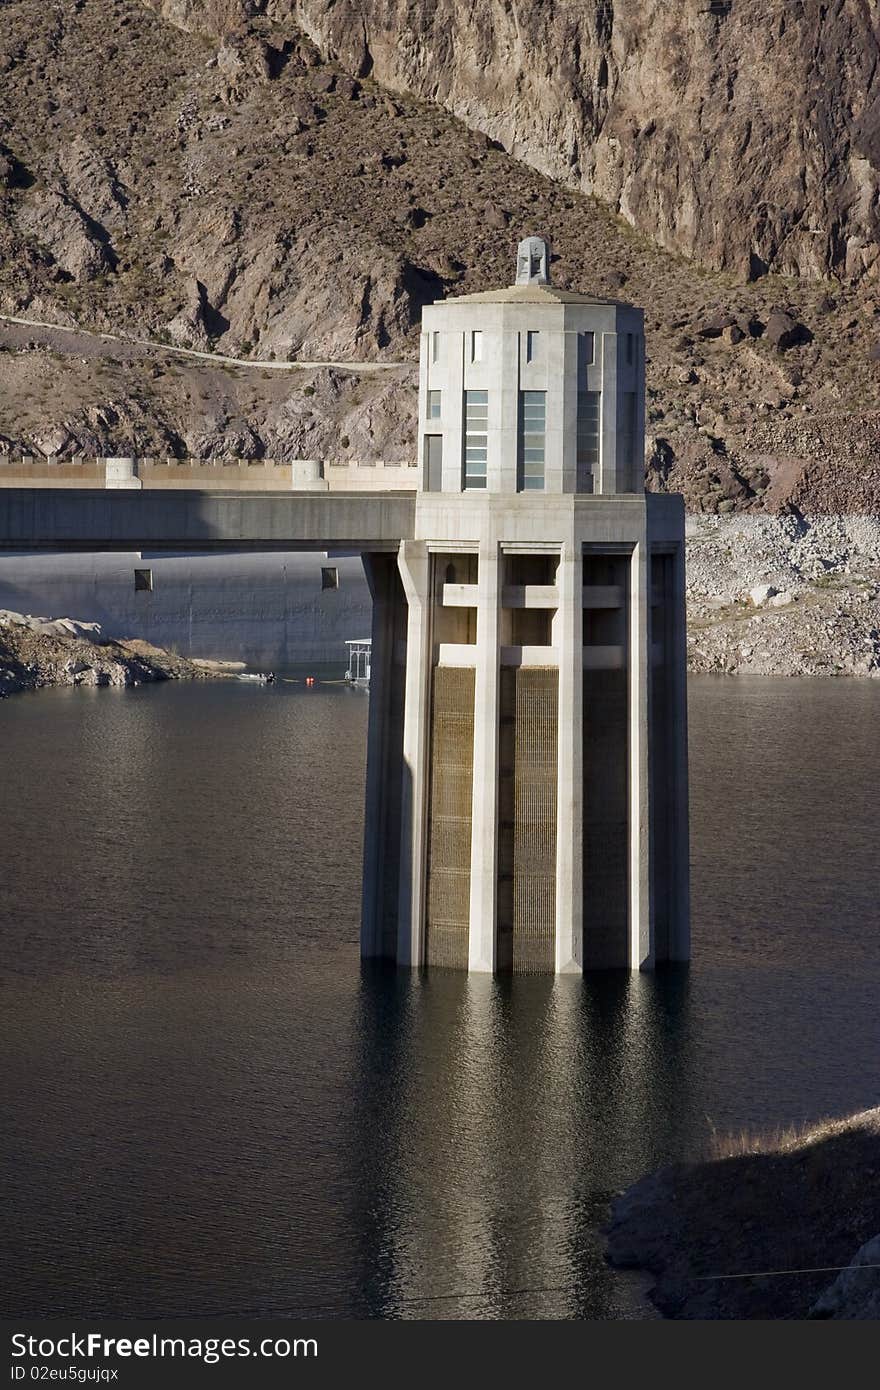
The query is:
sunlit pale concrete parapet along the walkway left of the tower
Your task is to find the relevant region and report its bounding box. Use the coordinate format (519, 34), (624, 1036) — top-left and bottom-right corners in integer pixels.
(0, 453), (417, 492)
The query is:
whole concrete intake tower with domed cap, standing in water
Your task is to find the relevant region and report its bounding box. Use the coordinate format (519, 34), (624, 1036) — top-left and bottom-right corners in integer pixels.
(361, 238), (690, 972)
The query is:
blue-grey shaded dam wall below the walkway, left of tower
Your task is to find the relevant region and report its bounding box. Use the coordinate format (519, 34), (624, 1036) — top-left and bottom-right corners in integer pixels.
(0, 550), (371, 669)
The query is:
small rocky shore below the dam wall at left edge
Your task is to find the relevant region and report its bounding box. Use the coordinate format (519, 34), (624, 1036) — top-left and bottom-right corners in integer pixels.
(0, 610), (243, 699)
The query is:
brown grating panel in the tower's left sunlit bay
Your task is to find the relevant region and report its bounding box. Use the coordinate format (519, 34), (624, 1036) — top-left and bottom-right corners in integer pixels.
(425, 666), (474, 970)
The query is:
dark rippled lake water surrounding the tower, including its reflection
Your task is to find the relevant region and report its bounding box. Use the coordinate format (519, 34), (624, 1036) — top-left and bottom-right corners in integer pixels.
(0, 678), (880, 1318)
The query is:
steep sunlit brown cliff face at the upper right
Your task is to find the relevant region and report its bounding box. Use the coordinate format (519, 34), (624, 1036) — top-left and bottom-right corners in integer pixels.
(278, 0), (880, 279)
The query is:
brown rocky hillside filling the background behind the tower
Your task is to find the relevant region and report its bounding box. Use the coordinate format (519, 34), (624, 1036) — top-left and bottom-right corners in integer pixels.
(0, 0), (880, 513)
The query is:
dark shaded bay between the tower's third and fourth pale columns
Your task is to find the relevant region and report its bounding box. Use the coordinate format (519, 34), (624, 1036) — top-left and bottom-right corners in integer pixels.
(584, 545), (631, 969)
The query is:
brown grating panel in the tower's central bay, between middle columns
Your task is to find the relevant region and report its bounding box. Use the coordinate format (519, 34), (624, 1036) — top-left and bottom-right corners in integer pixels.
(498, 667), (559, 973)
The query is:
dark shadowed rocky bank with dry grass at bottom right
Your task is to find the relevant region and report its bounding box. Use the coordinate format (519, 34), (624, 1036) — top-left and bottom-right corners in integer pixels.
(608, 1109), (880, 1319)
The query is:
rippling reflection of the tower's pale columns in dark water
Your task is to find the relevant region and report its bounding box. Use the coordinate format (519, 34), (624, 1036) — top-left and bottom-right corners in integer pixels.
(350, 966), (705, 1318)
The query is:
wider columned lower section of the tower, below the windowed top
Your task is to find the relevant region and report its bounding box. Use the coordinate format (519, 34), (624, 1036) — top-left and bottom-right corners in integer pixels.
(363, 493), (690, 973)
